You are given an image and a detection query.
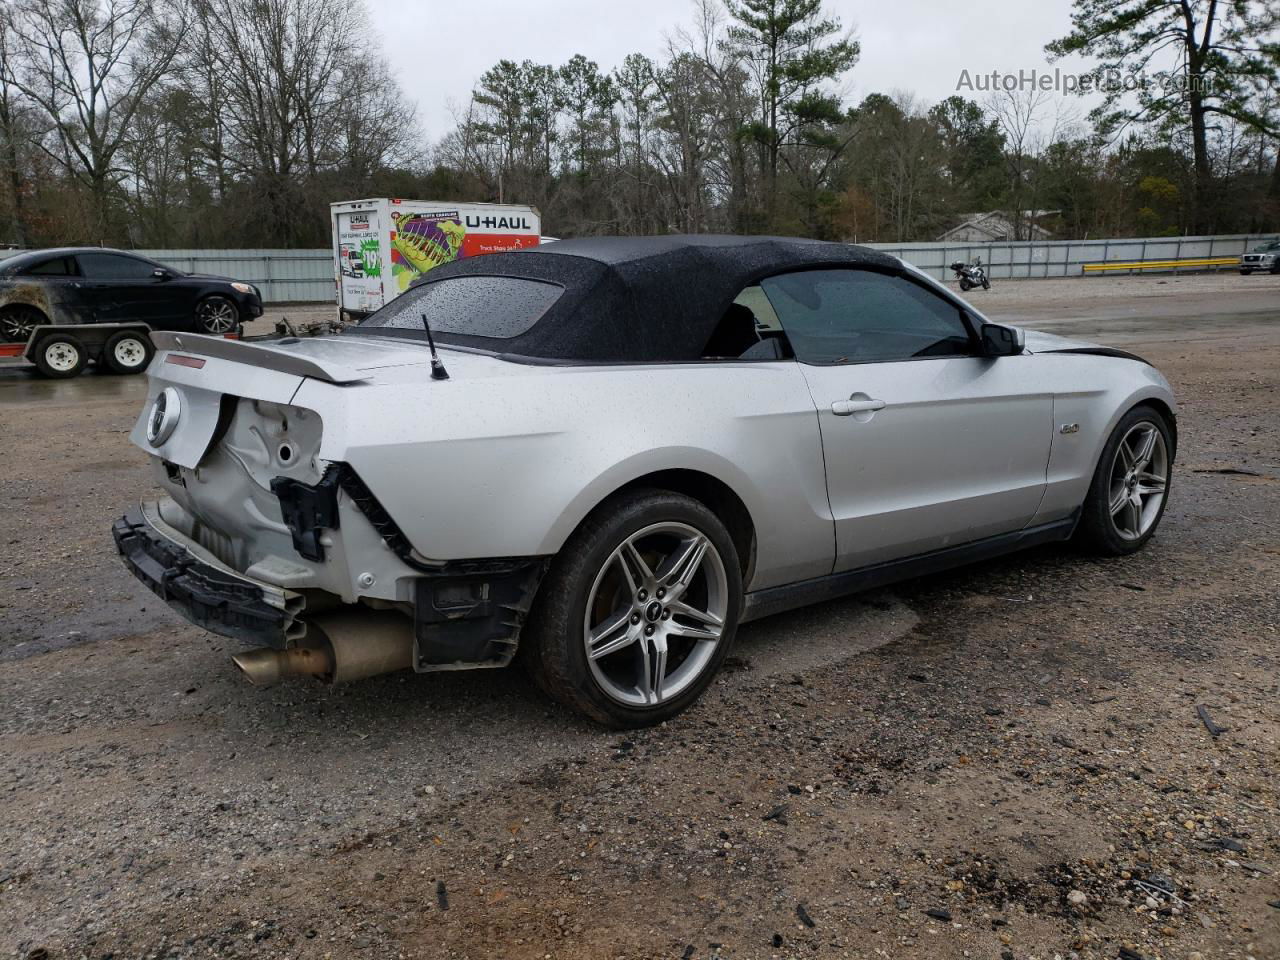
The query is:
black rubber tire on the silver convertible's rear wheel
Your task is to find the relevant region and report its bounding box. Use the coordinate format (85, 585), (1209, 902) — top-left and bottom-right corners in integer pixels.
(521, 490), (742, 727)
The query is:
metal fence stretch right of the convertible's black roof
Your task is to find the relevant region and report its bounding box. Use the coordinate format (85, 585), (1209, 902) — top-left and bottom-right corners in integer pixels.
(867, 234), (1272, 280)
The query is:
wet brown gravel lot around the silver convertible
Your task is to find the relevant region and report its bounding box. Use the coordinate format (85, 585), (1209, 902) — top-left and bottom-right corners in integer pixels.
(0, 276), (1280, 960)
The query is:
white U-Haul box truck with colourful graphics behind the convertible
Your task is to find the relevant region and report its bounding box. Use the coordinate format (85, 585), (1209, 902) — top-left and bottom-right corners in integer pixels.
(329, 198), (541, 320)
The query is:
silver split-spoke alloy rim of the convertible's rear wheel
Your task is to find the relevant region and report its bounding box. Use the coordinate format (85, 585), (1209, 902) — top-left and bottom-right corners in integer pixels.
(582, 522), (730, 707)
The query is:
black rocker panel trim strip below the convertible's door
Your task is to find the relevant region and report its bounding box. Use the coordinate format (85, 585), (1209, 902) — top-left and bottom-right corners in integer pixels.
(741, 511), (1079, 623)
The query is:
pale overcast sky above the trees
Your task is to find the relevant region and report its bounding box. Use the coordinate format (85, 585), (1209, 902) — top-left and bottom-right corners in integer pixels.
(369, 0), (1100, 141)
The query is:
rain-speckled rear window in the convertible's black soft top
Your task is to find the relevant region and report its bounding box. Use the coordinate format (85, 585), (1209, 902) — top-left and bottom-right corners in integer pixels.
(356, 276), (564, 340)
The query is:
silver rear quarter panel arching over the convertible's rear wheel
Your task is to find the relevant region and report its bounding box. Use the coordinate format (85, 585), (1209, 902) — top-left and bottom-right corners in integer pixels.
(294, 351), (831, 586)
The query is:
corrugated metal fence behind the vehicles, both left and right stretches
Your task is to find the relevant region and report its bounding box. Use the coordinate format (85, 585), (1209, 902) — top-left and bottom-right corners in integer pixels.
(0, 234), (1271, 303)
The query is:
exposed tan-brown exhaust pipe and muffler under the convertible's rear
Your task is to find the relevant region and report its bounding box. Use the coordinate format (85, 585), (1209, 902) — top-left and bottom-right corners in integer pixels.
(232, 609), (413, 686)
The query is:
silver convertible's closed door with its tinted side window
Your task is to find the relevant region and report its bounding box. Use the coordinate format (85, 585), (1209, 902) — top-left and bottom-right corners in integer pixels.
(760, 269), (1053, 572)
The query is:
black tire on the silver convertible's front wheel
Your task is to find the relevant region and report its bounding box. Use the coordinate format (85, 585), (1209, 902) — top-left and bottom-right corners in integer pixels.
(1076, 404), (1174, 557)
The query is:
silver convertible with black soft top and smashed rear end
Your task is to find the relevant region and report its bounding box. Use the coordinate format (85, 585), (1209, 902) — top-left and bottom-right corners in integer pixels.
(114, 237), (1176, 726)
